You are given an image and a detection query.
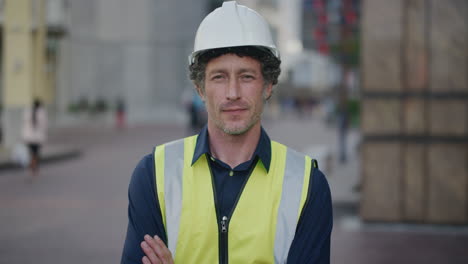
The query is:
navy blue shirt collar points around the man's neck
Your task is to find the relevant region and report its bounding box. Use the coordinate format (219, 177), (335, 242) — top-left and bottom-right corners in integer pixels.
(192, 125), (271, 172)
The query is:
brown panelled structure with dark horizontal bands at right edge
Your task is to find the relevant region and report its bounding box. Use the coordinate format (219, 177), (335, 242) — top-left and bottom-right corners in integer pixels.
(361, 0), (468, 224)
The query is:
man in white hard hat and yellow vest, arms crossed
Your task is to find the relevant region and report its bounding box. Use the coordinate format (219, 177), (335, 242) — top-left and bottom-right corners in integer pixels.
(122, 2), (332, 264)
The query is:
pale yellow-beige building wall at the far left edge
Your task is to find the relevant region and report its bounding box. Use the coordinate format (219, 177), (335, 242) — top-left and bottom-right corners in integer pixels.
(2, 0), (46, 148)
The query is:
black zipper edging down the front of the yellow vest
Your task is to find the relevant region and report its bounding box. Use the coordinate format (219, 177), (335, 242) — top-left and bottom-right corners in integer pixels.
(205, 154), (258, 264)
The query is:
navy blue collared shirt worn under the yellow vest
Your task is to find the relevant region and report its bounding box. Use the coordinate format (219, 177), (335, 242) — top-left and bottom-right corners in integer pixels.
(121, 126), (333, 264)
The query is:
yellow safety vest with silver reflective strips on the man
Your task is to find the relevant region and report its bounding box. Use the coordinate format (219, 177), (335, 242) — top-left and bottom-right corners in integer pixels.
(154, 136), (315, 264)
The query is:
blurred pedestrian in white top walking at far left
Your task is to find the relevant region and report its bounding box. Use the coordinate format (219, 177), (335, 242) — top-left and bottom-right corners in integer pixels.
(21, 99), (47, 176)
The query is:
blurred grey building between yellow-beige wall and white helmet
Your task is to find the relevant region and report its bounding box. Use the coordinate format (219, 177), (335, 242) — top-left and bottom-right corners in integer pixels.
(58, 0), (209, 123)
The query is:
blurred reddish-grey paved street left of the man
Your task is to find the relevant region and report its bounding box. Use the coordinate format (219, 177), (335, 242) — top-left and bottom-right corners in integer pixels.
(0, 124), (183, 264)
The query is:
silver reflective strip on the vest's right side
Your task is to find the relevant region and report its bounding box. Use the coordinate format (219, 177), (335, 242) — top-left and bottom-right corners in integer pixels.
(275, 148), (306, 263)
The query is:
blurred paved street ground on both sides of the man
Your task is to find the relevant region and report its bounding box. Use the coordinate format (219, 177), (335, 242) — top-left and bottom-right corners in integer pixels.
(0, 118), (468, 264)
